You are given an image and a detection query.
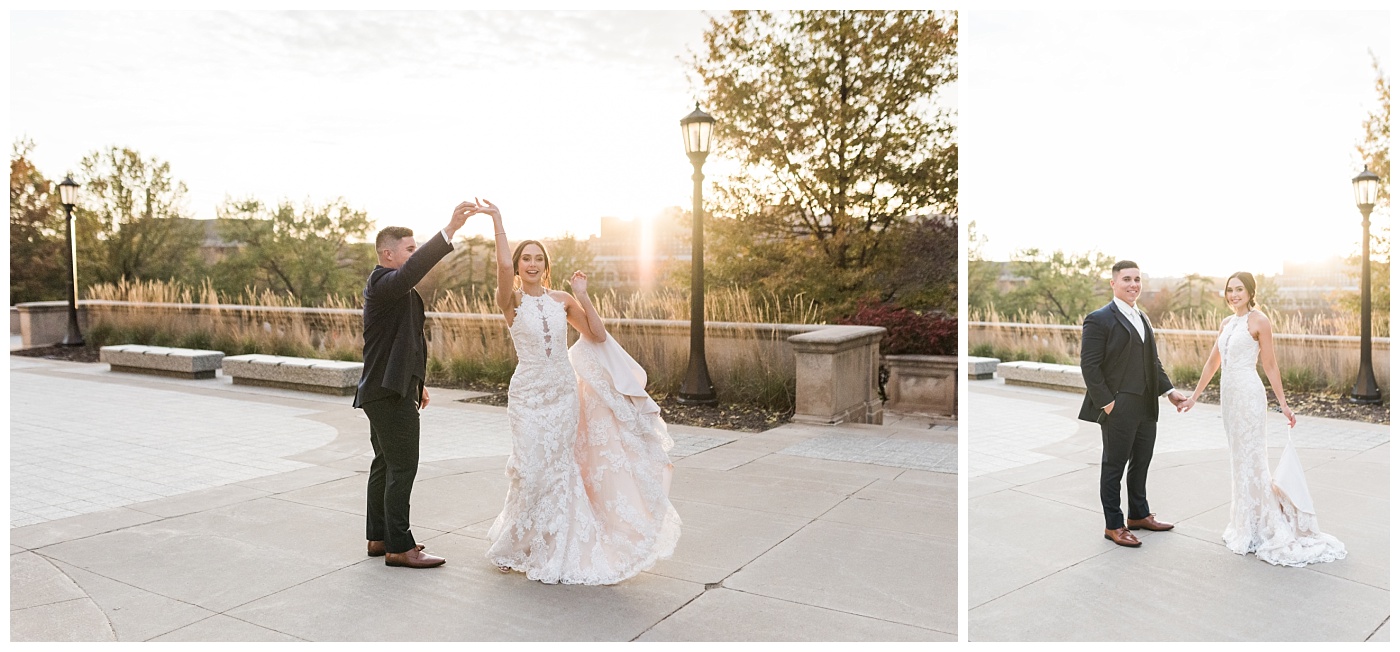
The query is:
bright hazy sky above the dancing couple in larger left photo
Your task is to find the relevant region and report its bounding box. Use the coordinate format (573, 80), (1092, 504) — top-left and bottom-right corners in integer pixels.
(10, 11), (725, 244)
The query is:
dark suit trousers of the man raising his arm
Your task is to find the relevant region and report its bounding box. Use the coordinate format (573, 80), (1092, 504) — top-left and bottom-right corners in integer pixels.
(361, 395), (419, 553)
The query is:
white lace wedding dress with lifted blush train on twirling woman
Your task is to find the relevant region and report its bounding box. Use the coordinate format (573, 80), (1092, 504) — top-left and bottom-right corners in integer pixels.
(486, 294), (680, 585)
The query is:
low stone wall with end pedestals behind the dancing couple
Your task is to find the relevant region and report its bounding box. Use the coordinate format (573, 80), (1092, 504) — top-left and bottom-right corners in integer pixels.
(18, 299), (885, 424)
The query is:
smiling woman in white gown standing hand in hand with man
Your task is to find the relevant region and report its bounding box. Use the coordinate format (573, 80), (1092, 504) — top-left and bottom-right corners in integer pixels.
(1180, 271), (1347, 567)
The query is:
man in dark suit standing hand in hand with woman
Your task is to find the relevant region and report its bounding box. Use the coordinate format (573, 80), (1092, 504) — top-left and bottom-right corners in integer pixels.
(1079, 260), (1186, 547)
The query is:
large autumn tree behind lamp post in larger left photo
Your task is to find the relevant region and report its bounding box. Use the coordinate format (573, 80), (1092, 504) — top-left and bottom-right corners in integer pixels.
(682, 11), (958, 318)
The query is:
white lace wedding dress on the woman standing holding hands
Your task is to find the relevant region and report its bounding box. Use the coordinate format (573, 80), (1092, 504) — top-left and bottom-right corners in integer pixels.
(1217, 315), (1347, 567)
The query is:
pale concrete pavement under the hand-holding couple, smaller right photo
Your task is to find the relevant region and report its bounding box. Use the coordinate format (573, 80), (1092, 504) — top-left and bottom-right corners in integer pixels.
(966, 381), (1390, 642)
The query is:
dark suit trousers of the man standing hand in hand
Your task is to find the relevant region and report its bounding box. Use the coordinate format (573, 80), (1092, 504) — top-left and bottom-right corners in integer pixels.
(1099, 393), (1156, 530)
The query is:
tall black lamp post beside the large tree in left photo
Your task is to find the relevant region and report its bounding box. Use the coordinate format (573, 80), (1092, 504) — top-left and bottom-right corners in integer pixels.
(680, 102), (718, 406)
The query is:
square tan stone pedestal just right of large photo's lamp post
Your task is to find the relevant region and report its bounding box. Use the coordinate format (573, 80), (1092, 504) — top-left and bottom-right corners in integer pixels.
(788, 326), (885, 424)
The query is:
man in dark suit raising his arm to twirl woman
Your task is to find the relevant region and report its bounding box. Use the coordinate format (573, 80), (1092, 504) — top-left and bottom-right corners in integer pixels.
(354, 201), (476, 568)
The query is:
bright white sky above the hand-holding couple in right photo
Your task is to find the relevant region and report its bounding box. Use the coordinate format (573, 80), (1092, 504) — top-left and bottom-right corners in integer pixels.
(959, 11), (1392, 276)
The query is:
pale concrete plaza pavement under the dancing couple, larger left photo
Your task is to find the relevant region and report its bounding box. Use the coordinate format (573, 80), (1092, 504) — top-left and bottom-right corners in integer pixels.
(8, 357), (958, 641)
